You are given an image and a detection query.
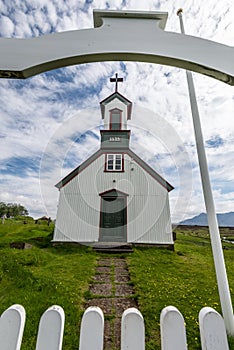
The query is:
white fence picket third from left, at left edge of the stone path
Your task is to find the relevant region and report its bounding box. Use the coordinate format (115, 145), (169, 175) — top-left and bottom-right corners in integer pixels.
(79, 306), (104, 350)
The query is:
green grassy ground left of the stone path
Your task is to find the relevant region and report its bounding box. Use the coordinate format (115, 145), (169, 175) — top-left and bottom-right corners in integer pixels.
(0, 223), (96, 350)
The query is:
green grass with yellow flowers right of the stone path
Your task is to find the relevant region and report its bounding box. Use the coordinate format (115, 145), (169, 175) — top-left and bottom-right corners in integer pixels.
(128, 231), (234, 350)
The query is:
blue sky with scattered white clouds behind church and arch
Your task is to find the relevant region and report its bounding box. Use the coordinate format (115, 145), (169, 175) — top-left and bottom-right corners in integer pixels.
(0, 0), (234, 222)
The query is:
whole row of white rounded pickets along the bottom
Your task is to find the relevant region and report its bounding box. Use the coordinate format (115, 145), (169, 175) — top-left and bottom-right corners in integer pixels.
(0, 305), (229, 350)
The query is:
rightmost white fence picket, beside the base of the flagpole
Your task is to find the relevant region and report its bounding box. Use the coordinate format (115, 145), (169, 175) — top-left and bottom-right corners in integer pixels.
(199, 307), (229, 350)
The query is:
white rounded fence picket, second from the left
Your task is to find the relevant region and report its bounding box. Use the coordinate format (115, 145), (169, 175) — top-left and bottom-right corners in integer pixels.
(36, 305), (65, 350)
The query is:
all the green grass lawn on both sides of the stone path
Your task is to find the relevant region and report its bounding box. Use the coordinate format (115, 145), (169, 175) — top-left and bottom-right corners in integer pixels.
(0, 220), (234, 350)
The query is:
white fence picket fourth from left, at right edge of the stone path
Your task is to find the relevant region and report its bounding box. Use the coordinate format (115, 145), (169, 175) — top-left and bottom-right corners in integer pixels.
(121, 307), (145, 350)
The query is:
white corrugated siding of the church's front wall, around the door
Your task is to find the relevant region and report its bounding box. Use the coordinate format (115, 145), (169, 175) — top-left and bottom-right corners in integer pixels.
(53, 154), (173, 244)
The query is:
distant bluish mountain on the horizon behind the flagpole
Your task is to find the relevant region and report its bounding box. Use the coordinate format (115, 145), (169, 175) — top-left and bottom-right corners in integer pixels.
(179, 212), (234, 227)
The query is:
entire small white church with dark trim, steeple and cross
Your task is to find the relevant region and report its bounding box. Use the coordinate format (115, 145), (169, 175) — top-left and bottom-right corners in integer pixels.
(53, 74), (174, 245)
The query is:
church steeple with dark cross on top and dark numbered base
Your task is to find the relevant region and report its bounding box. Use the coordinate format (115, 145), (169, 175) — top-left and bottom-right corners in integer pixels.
(100, 73), (132, 149)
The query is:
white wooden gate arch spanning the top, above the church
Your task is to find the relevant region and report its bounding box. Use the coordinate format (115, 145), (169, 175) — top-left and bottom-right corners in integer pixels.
(0, 10), (234, 85)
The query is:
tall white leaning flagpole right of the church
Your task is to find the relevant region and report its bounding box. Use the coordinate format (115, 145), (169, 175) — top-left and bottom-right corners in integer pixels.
(177, 9), (234, 336)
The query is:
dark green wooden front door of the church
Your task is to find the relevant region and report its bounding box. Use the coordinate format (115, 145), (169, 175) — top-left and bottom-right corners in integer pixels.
(99, 195), (127, 242)
